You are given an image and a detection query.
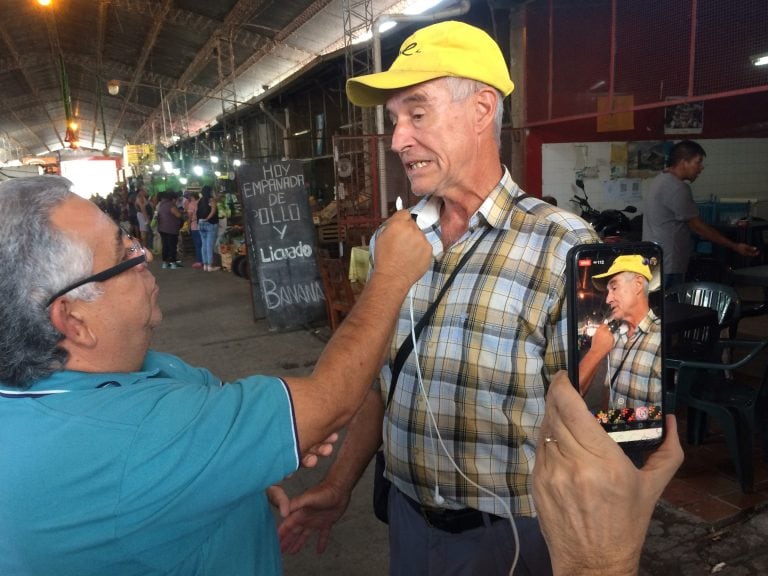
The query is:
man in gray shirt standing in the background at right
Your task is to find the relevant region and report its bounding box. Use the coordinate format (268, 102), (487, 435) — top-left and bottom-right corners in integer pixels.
(643, 140), (759, 289)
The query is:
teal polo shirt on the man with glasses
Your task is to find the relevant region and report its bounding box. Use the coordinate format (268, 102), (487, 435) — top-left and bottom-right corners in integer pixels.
(0, 351), (300, 576)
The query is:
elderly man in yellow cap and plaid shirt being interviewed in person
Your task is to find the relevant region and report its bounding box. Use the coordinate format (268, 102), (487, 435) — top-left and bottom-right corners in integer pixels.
(280, 21), (597, 576)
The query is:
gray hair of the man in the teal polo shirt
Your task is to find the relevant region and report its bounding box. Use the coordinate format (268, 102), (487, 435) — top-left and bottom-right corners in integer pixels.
(0, 176), (101, 388)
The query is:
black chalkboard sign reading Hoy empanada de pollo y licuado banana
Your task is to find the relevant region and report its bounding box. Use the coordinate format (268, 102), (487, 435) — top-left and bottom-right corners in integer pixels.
(237, 160), (325, 331)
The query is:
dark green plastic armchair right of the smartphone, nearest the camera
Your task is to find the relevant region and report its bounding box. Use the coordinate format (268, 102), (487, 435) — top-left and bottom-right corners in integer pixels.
(666, 339), (768, 493)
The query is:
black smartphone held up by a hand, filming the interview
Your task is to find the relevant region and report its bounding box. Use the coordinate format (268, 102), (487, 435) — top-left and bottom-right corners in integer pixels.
(566, 242), (667, 450)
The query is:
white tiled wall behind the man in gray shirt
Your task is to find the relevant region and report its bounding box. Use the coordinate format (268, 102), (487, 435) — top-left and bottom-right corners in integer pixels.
(542, 138), (768, 219)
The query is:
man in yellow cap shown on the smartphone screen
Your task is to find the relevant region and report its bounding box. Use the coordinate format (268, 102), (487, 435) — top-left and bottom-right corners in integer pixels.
(579, 254), (662, 410)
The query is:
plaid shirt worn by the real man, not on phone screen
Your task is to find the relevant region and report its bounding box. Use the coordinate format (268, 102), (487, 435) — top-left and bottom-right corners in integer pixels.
(371, 170), (597, 516)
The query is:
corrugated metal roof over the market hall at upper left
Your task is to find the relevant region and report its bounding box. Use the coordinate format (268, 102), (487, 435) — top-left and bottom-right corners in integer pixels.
(0, 0), (420, 162)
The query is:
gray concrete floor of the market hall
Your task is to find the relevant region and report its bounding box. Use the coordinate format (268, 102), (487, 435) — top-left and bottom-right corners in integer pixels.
(152, 262), (768, 576)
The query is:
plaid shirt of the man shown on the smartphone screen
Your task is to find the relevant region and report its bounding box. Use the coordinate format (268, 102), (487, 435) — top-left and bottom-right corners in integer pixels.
(606, 310), (662, 410)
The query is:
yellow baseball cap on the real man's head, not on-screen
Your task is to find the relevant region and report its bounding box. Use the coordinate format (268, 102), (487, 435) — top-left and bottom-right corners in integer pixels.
(347, 20), (515, 106)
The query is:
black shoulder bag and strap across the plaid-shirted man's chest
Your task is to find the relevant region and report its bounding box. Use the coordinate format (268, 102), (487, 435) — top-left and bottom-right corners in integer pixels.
(373, 227), (492, 524)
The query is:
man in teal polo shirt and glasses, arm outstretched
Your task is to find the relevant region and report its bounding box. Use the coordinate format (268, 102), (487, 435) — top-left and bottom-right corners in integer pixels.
(0, 176), (431, 576)
